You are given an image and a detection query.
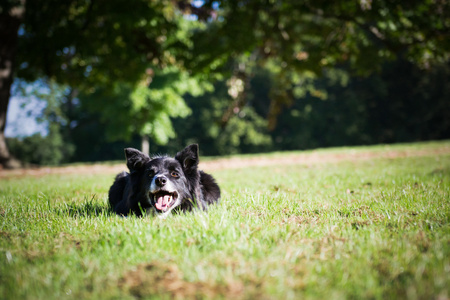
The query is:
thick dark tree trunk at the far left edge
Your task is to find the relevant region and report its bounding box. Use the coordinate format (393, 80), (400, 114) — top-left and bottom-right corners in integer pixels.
(0, 3), (25, 168)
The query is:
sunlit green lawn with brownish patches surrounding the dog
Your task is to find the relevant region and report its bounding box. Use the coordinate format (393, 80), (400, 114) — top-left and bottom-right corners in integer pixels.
(0, 142), (450, 299)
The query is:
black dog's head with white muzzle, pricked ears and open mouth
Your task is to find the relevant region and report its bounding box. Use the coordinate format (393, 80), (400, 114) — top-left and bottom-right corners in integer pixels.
(125, 144), (199, 216)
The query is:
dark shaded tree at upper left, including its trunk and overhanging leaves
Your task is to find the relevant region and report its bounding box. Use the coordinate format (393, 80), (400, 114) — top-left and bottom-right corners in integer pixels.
(0, 0), (202, 167)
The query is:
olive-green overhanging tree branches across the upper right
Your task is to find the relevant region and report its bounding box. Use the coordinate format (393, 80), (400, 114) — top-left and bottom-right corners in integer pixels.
(187, 0), (450, 128)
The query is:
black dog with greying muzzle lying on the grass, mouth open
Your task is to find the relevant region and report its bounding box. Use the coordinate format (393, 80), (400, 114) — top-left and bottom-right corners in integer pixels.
(108, 144), (220, 218)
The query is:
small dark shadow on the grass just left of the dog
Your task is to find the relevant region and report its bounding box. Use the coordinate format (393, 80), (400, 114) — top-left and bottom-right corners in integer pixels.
(56, 196), (115, 218)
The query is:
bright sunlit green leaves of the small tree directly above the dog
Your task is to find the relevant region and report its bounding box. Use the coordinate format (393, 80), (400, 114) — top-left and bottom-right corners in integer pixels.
(78, 67), (212, 144)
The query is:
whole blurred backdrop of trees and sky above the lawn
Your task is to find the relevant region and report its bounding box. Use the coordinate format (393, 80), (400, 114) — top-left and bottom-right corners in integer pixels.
(0, 0), (450, 168)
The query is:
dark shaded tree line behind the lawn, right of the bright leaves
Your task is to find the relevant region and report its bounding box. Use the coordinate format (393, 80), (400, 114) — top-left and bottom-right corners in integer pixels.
(156, 61), (450, 155)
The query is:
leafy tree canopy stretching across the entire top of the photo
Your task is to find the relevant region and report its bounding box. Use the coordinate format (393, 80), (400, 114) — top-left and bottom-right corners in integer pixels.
(0, 0), (450, 164)
